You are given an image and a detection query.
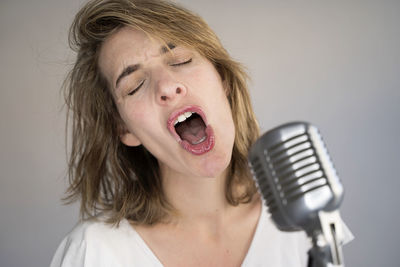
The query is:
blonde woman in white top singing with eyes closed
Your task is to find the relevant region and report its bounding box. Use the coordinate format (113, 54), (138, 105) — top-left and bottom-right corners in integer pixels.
(51, 0), (307, 266)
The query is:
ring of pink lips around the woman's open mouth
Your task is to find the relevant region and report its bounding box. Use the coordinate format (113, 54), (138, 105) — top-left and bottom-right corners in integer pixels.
(167, 105), (215, 155)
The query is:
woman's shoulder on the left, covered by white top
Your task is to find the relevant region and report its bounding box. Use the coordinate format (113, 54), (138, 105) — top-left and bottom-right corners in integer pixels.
(50, 219), (157, 267)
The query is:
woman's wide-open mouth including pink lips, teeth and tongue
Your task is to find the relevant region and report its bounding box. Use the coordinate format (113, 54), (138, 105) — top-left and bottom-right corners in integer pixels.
(168, 106), (214, 155)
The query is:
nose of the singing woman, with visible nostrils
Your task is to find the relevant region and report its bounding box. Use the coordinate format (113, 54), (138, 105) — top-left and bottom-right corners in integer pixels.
(156, 70), (187, 105)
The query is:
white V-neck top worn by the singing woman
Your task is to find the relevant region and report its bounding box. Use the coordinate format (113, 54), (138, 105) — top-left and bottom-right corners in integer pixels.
(50, 206), (311, 267)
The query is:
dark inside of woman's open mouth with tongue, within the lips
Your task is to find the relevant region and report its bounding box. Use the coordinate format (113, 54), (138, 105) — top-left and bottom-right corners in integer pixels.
(176, 116), (206, 145)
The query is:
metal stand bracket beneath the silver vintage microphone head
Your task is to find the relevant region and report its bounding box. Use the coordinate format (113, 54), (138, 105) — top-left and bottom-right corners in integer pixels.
(307, 210), (344, 267)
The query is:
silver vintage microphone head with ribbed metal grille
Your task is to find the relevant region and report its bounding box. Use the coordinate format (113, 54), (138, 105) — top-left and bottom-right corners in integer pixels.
(249, 122), (343, 232)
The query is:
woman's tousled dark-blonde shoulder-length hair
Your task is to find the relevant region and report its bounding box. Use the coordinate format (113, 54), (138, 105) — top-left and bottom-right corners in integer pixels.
(64, 0), (259, 224)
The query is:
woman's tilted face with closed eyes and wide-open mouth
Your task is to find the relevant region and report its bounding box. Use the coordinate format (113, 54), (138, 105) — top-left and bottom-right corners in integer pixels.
(99, 27), (235, 177)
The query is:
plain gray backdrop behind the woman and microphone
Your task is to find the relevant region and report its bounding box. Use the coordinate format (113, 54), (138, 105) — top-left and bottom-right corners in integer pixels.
(0, 0), (400, 267)
